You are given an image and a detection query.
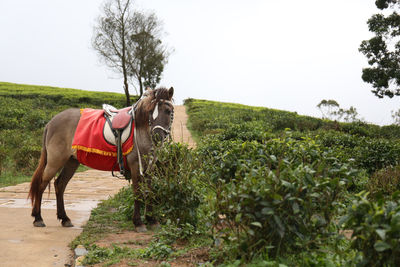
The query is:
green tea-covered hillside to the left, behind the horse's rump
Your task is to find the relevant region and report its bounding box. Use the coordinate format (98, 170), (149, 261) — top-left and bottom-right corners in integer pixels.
(0, 82), (136, 184)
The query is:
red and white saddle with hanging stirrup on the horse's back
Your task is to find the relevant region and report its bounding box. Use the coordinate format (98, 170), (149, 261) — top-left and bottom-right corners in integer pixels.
(103, 104), (133, 179)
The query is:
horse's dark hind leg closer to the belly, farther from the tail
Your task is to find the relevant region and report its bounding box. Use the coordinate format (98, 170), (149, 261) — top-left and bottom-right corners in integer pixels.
(54, 157), (79, 227)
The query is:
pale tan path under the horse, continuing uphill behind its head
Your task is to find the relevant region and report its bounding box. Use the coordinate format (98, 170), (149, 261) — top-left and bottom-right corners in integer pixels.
(0, 106), (195, 267)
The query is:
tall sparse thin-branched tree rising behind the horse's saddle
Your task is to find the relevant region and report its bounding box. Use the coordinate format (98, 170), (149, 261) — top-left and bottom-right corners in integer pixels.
(92, 0), (169, 106)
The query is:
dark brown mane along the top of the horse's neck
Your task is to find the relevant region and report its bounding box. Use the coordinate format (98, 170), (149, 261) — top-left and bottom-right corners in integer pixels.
(135, 87), (171, 128)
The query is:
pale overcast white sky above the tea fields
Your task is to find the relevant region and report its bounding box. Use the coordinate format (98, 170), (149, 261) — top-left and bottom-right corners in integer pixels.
(0, 0), (400, 125)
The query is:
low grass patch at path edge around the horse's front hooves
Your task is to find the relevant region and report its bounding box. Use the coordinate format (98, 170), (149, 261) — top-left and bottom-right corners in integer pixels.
(70, 187), (209, 266)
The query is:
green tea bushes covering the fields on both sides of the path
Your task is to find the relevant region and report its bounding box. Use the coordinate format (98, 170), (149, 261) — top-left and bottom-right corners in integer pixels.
(0, 83), (400, 266)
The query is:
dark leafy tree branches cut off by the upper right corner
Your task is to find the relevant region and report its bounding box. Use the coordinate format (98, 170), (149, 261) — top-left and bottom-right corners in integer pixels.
(359, 0), (400, 98)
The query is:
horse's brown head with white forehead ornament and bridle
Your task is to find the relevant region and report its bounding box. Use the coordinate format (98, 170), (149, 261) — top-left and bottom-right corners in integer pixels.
(135, 87), (174, 144)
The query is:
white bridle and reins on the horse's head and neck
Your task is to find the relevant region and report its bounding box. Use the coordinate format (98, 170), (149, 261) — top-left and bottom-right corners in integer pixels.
(132, 93), (174, 176)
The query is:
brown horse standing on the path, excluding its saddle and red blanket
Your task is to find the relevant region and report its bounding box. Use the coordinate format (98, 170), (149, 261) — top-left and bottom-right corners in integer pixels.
(28, 87), (174, 231)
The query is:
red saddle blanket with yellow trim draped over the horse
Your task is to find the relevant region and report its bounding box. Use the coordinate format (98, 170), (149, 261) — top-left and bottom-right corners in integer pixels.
(72, 108), (134, 171)
